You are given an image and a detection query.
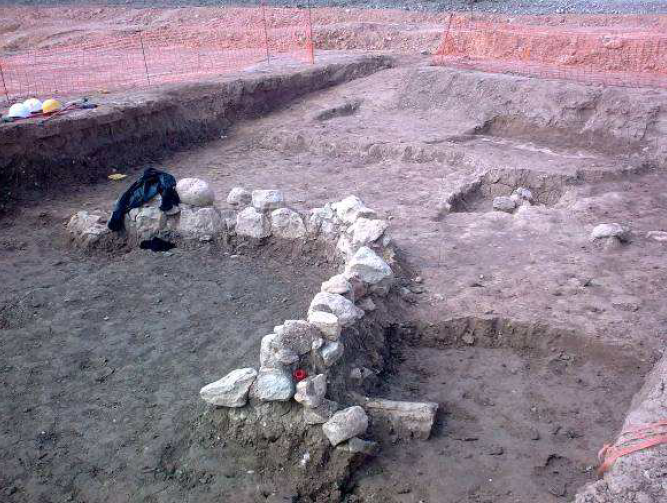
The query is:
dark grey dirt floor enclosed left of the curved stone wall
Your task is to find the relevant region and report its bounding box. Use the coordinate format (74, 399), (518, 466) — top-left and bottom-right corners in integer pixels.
(0, 218), (330, 503)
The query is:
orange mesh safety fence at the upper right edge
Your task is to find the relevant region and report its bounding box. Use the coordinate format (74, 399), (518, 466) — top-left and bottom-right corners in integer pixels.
(434, 14), (667, 88)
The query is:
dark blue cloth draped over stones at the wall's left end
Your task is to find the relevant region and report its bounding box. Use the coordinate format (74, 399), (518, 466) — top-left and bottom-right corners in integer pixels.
(107, 168), (181, 232)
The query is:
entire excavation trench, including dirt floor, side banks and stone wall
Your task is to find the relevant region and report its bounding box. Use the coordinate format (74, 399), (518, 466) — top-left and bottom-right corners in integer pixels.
(0, 57), (665, 503)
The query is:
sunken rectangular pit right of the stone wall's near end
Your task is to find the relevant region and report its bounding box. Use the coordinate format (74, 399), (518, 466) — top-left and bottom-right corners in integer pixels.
(353, 318), (654, 503)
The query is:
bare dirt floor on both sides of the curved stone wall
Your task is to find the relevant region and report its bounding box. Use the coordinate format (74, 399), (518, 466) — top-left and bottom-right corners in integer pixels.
(0, 20), (667, 503)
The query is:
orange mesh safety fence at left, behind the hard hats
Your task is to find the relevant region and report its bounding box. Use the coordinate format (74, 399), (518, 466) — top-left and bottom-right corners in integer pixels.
(0, 7), (314, 101)
